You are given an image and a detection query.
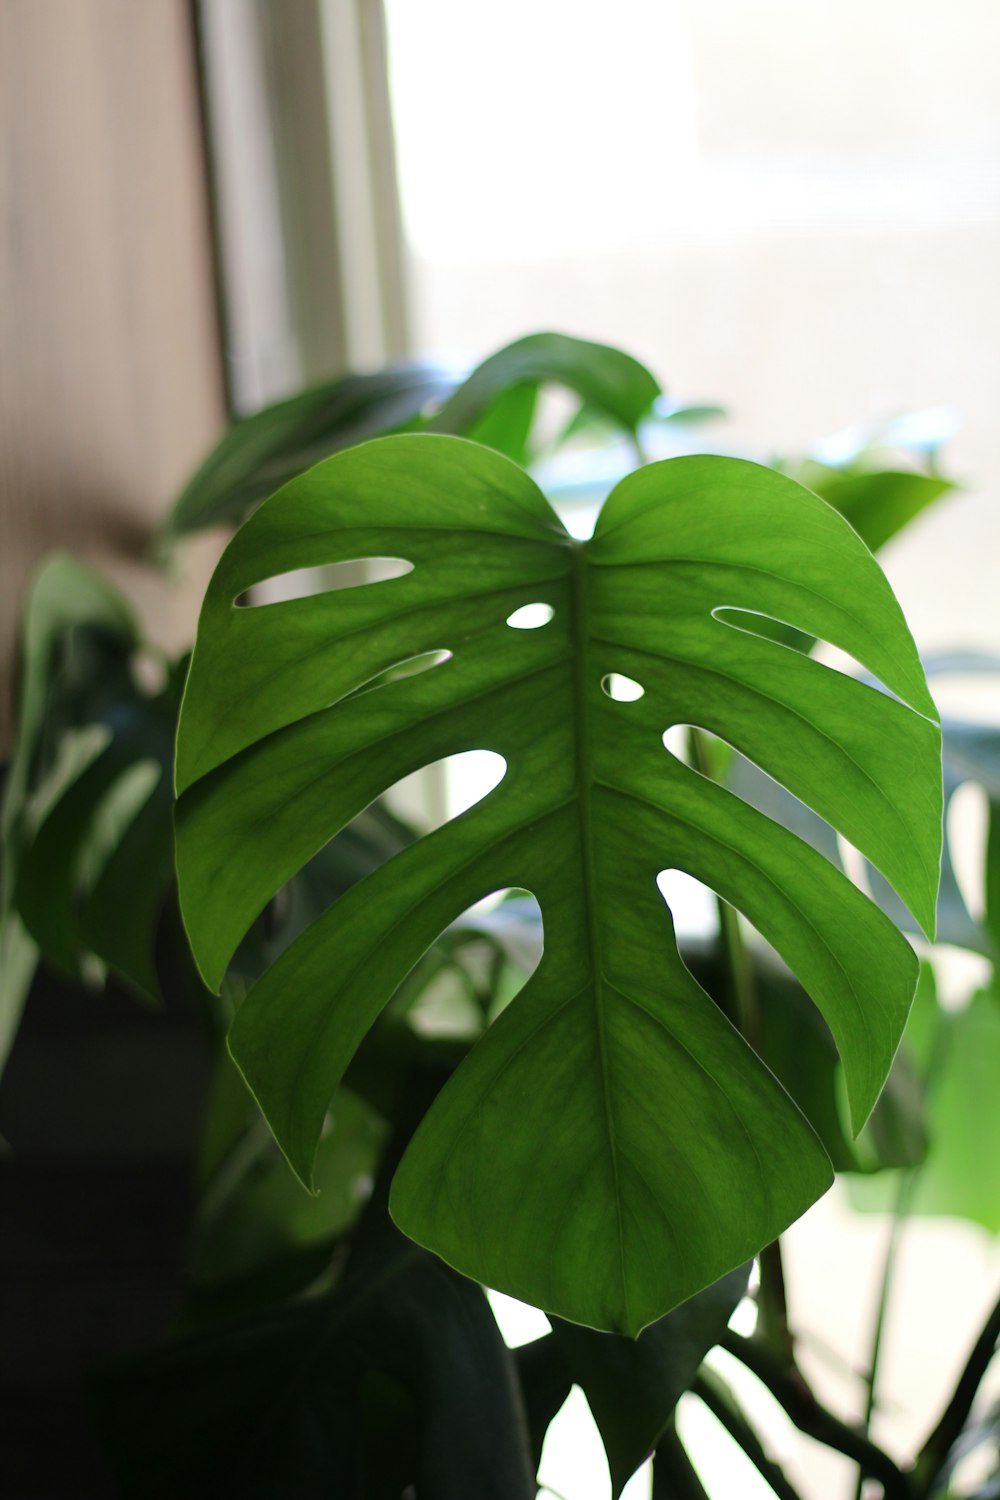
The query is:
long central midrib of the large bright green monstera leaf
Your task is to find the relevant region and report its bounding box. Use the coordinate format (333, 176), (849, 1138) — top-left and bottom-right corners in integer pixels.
(570, 542), (631, 1326)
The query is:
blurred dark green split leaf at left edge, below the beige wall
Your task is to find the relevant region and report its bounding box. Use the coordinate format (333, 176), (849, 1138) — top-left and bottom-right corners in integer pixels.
(0, 554), (170, 1062)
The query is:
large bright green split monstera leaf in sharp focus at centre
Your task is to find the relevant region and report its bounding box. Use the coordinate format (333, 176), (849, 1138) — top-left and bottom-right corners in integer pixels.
(177, 434), (942, 1334)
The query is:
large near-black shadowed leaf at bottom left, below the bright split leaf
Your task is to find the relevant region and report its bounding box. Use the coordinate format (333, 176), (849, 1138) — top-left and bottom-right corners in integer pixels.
(94, 1230), (535, 1500)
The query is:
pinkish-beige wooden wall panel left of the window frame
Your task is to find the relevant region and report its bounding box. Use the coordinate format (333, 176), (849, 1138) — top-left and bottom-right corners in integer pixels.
(0, 0), (223, 746)
